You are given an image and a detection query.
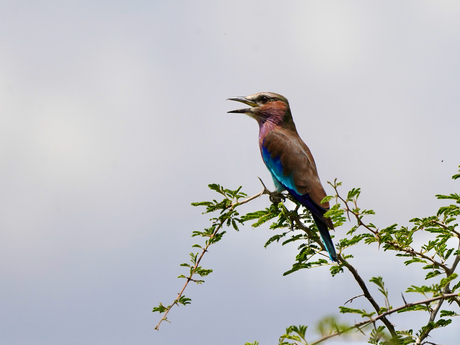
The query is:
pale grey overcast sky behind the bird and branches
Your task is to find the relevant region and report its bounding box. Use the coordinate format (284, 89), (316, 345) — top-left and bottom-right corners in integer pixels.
(0, 0), (460, 345)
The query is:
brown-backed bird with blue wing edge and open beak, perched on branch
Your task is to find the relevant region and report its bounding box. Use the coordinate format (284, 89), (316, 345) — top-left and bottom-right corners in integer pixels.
(227, 92), (337, 262)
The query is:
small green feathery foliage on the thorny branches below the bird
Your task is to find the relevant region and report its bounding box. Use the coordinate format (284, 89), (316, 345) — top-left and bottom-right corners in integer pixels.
(153, 167), (460, 345)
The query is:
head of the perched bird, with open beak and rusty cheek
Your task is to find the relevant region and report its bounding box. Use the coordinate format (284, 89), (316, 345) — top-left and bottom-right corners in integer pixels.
(228, 92), (293, 125)
